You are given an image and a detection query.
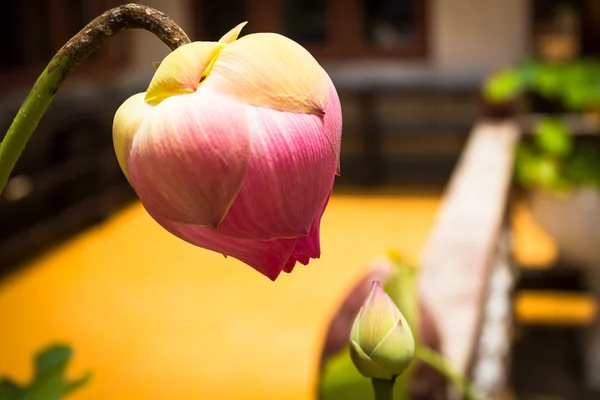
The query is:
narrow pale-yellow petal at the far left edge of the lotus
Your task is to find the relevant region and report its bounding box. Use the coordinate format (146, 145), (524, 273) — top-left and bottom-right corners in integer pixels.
(113, 93), (152, 183)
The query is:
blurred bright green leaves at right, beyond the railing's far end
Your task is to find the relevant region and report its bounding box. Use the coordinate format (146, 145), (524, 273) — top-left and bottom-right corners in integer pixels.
(483, 59), (600, 192)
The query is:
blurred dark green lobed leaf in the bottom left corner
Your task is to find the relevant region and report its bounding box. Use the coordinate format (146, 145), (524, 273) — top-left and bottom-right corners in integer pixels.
(0, 345), (91, 400)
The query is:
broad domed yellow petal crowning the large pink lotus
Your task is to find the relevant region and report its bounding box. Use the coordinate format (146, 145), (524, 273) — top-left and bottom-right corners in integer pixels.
(202, 33), (329, 114)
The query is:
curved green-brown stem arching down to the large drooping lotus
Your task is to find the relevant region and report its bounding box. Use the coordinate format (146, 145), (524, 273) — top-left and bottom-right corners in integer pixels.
(0, 4), (190, 194)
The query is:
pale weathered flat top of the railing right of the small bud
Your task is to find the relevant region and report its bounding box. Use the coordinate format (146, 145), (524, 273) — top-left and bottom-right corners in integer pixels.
(419, 121), (520, 396)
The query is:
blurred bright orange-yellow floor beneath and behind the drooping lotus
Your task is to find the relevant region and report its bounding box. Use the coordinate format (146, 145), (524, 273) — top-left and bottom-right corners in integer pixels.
(0, 195), (589, 400)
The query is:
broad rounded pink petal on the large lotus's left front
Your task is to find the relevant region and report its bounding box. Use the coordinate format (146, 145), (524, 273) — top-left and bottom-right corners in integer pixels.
(129, 92), (250, 227)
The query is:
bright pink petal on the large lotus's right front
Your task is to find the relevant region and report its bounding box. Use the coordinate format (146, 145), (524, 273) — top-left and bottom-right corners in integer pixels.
(218, 106), (337, 239)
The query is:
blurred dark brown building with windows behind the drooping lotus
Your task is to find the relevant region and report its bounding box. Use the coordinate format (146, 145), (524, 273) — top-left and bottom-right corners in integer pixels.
(0, 0), (600, 265)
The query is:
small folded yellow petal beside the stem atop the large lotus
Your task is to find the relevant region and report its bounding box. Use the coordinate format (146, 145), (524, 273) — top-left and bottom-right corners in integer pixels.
(145, 42), (226, 106)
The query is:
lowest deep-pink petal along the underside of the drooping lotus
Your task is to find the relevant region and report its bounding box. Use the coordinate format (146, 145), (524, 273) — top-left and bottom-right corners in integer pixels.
(148, 210), (298, 281)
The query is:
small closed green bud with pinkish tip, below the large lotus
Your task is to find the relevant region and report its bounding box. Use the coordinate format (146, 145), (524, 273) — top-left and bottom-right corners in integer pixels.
(350, 281), (415, 380)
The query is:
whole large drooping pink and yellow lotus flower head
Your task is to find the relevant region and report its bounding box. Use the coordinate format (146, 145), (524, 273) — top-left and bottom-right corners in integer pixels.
(113, 24), (342, 280)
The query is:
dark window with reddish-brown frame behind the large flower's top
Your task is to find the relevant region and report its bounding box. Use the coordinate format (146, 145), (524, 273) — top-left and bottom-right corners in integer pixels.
(192, 0), (428, 59)
